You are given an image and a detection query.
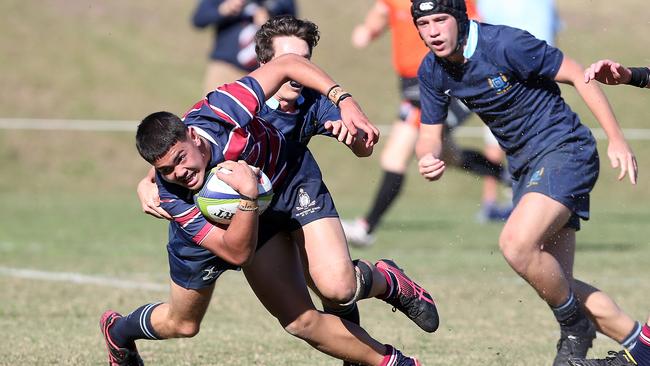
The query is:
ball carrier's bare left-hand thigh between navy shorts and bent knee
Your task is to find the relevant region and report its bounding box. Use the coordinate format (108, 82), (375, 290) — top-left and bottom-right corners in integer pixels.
(168, 281), (214, 323)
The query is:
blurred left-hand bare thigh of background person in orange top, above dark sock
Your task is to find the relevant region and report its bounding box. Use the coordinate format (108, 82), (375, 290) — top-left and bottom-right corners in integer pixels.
(381, 121), (418, 173)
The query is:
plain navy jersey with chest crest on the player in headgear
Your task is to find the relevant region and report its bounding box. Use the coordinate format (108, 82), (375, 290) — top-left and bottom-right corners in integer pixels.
(418, 22), (593, 176)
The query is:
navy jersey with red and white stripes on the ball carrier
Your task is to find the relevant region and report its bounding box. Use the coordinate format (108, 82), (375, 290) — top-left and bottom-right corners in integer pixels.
(156, 77), (288, 246)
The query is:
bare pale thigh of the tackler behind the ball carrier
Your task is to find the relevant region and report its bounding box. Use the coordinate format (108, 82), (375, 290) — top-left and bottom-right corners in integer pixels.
(292, 217), (356, 300)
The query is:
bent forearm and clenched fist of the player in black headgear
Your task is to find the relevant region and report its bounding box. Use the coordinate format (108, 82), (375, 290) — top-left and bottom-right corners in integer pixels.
(415, 123), (445, 181)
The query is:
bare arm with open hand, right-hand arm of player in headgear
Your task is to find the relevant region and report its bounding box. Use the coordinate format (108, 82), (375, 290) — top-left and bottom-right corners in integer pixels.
(555, 56), (638, 184)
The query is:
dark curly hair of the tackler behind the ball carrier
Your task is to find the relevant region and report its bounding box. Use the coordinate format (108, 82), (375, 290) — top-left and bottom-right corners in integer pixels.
(255, 15), (320, 63)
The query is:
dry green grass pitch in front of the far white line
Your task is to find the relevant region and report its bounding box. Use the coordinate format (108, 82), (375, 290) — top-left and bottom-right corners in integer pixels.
(0, 131), (650, 365)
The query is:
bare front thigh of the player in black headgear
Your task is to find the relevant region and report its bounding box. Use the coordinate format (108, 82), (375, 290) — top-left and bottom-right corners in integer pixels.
(499, 192), (571, 251)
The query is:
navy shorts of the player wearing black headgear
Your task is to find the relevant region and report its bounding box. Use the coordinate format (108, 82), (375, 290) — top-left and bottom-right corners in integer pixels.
(512, 139), (600, 230)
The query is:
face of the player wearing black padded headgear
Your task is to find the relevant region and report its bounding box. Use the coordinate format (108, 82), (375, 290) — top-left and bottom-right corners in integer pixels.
(415, 13), (458, 58)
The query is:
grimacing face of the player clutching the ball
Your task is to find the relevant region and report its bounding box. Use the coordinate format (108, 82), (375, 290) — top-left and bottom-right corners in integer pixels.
(154, 130), (209, 190)
